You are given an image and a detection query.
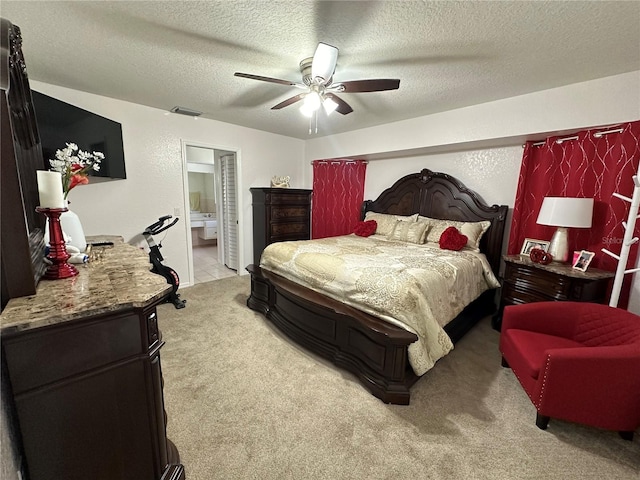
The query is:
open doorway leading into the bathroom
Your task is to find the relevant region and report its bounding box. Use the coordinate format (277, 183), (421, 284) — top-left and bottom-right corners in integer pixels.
(184, 142), (238, 285)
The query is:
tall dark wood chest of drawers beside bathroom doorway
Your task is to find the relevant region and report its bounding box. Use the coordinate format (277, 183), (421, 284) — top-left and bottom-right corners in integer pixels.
(250, 188), (312, 265)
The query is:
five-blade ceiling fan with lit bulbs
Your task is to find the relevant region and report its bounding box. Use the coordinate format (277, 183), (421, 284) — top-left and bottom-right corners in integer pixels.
(234, 42), (400, 127)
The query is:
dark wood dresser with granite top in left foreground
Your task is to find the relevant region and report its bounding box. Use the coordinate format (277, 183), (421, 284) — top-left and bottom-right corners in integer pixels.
(0, 237), (185, 480)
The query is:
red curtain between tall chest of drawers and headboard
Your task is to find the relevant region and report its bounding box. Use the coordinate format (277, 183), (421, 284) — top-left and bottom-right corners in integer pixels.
(311, 160), (367, 238)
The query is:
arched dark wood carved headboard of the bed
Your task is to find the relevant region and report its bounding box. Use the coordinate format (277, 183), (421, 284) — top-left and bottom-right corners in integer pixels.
(361, 168), (508, 276)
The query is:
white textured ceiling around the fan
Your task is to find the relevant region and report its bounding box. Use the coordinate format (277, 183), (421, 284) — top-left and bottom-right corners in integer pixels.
(0, 0), (640, 139)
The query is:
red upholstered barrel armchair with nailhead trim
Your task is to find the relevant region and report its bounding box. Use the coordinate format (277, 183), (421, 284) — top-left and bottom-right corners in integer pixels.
(500, 302), (640, 440)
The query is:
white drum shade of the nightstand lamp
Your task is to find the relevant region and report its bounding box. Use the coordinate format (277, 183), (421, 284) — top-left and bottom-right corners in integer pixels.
(537, 197), (593, 228)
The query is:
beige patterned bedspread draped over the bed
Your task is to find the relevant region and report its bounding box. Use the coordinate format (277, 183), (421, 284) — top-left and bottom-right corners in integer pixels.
(260, 235), (499, 375)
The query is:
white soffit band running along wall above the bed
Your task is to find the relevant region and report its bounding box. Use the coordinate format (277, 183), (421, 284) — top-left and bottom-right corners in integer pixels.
(306, 71), (640, 161)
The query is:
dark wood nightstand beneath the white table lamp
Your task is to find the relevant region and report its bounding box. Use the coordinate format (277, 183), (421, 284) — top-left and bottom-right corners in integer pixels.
(492, 255), (615, 330)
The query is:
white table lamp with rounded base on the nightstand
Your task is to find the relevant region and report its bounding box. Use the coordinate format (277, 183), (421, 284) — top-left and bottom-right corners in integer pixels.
(536, 197), (593, 262)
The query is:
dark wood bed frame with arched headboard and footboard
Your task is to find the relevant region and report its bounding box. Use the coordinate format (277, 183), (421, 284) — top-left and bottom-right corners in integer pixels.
(247, 169), (508, 405)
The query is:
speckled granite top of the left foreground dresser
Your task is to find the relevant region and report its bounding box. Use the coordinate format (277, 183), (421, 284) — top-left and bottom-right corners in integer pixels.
(0, 235), (171, 335)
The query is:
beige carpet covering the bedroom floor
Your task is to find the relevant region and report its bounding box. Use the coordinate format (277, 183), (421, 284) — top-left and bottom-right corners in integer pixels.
(159, 276), (640, 480)
